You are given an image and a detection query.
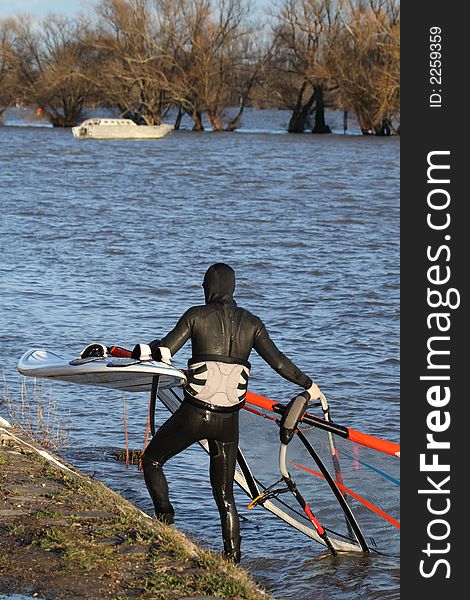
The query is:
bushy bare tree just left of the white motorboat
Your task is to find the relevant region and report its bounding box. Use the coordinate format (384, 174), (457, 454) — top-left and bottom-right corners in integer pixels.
(14, 15), (96, 127)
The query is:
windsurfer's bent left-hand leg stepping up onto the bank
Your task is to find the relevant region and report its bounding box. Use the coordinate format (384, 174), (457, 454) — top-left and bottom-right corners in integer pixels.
(142, 403), (201, 524)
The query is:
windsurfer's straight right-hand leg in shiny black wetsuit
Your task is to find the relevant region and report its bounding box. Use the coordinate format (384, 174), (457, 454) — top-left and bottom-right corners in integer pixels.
(209, 440), (241, 562)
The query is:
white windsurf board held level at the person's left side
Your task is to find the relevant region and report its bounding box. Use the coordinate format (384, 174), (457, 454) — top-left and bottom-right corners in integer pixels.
(18, 348), (186, 392)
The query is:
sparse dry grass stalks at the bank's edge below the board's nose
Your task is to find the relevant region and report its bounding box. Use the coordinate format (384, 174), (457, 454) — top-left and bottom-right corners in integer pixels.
(2, 371), (70, 451)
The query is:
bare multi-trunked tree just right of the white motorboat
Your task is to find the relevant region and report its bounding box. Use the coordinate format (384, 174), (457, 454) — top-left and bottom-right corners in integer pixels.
(159, 0), (260, 131)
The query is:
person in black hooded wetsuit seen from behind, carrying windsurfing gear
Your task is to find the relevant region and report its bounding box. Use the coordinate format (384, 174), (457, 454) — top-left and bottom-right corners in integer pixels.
(142, 263), (320, 562)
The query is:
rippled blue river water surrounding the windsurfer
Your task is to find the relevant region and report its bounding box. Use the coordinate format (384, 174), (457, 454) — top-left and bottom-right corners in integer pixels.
(0, 111), (400, 600)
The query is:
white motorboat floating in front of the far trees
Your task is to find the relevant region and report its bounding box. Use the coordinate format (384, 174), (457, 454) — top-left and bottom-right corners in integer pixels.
(72, 118), (173, 140)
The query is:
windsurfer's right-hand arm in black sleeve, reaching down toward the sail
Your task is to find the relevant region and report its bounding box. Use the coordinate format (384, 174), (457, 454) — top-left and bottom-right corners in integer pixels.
(253, 323), (320, 400)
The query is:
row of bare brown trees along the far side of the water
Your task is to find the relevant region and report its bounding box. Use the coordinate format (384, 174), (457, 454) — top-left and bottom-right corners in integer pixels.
(0, 0), (400, 135)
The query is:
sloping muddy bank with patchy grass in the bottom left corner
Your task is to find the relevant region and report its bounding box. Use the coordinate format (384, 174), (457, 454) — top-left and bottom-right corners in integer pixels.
(0, 422), (270, 600)
